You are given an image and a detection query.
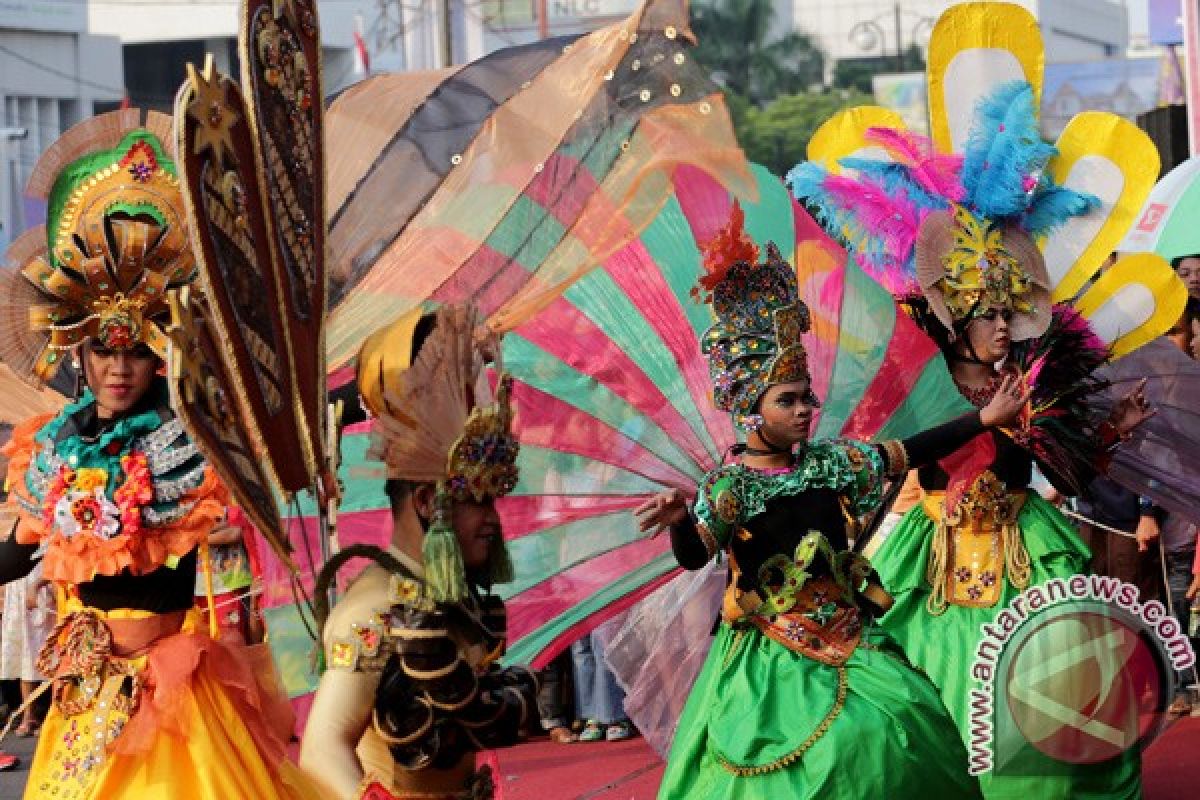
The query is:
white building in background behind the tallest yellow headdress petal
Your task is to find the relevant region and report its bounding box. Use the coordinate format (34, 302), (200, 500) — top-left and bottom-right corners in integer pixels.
(775, 0), (1129, 79)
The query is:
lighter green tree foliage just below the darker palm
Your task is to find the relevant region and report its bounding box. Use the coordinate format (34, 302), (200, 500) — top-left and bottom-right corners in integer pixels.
(726, 89), (875, 175)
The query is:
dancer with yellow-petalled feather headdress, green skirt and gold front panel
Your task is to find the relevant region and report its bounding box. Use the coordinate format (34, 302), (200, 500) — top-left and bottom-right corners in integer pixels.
(788, 4), (1183, 798)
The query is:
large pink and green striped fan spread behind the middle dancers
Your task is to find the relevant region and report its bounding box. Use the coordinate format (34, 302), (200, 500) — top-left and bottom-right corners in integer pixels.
(250, 160), (968, 686)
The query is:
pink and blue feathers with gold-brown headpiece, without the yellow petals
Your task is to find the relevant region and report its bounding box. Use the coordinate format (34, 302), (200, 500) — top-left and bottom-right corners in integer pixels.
(788, 80), (1099, 341)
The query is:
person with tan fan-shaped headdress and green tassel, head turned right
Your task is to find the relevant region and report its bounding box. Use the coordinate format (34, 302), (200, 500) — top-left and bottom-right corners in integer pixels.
(301, 306), (538, 800)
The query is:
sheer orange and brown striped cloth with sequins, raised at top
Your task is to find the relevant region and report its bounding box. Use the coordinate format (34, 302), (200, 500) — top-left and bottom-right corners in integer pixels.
(326, 0), (750, 365)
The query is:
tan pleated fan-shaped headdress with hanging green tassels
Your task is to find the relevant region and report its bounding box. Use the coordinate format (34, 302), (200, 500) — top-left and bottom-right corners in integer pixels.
(358, 306), (518, 602)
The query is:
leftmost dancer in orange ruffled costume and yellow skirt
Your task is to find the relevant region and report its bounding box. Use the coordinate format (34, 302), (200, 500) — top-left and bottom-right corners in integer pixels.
(0, 109), (317, 800)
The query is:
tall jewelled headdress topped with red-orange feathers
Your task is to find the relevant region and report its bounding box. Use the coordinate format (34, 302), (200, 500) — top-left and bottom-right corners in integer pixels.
(694, 203), (809, 432)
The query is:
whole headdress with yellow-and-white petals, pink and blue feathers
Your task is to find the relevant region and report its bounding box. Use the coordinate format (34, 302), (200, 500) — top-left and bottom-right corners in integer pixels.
(787, 2), (1181, 356)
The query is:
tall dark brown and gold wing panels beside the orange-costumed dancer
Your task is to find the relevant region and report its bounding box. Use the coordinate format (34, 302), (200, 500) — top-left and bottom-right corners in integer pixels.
(172, 0), (328, 551)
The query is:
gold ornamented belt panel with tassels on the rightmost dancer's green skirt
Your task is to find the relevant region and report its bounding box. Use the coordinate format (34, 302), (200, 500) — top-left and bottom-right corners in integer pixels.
(922, 471), (1030, 614)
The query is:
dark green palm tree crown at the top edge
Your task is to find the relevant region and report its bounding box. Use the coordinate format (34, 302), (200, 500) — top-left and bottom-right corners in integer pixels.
(692, 0), (824, 106)
